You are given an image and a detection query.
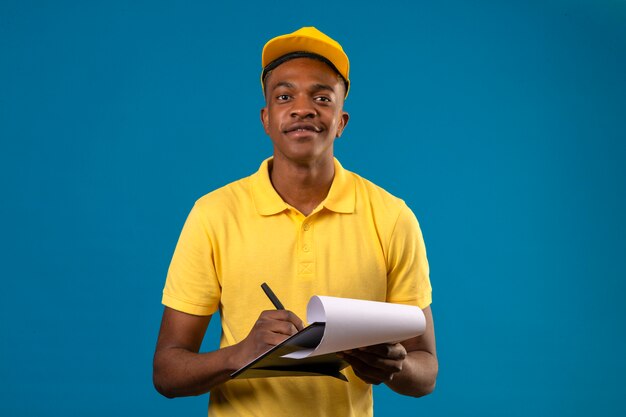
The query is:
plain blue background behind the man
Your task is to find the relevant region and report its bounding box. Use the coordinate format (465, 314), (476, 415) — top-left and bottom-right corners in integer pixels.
(0, 0), (626, 416)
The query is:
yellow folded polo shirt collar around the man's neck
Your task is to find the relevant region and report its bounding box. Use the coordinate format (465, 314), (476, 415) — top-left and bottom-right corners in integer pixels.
(251, 158), (356, 216)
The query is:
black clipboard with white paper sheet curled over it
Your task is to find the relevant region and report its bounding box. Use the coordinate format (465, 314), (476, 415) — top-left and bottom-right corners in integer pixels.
(230, 295), (426, 381)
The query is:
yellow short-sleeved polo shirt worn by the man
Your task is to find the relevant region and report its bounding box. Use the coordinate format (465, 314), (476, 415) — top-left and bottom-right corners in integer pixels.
(163, 159), (431, 417)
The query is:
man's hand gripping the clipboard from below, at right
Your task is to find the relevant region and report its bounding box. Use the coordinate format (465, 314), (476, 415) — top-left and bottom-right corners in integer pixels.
(338, 343), (407, 385)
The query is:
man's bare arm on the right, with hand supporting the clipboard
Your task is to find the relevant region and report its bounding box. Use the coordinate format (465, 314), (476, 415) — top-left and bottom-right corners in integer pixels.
(340, 306), (438, 397)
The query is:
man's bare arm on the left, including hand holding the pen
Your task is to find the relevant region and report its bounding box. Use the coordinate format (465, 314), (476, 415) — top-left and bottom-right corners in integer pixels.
(153, 307), (302, 398)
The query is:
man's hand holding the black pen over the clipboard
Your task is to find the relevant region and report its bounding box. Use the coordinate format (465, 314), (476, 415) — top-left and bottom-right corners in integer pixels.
(235, 310), (303, 369)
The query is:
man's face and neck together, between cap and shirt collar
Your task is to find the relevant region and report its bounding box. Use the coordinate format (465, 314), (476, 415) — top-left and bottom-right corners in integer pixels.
(261, 58), (350, 215)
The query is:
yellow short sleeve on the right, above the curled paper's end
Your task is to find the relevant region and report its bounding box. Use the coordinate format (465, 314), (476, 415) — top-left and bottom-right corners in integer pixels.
(387, 205), (432, 309)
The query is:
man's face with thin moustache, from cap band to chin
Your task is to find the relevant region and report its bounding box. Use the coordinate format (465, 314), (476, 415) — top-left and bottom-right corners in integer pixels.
(261, 58), (349, 164)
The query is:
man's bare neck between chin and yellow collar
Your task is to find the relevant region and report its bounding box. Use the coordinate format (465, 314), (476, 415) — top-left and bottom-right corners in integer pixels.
(270, 155), (335, 216)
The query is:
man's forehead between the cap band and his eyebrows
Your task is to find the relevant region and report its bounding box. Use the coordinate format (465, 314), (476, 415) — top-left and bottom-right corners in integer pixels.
(266, 58), (342, 91)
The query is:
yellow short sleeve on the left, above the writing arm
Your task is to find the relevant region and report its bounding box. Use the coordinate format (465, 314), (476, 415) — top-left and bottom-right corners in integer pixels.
(162, 204), (221, 316)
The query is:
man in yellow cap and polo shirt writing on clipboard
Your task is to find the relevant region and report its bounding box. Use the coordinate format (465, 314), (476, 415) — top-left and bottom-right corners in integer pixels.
(154, 28), (437, 416)
